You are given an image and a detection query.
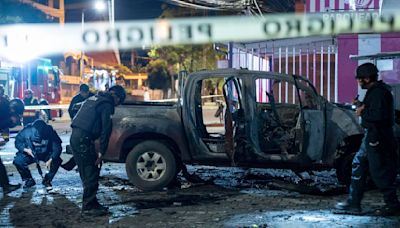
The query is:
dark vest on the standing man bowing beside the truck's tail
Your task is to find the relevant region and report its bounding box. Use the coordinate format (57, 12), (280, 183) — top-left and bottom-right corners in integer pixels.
(71, 95), (114, 138)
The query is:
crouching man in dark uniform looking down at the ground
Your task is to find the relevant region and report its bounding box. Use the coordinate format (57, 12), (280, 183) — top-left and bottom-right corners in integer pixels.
(13, 120), (62, 189)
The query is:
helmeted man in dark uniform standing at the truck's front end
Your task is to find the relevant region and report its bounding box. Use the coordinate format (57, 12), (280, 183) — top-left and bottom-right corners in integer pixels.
(336, 63), (400, 216)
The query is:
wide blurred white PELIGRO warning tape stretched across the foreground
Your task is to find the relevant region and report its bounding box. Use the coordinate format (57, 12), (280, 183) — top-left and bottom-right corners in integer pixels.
(0, 12), (400, 59)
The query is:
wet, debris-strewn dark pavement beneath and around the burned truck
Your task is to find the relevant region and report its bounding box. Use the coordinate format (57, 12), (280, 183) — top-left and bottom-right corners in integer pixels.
(0, 118), (400, 227)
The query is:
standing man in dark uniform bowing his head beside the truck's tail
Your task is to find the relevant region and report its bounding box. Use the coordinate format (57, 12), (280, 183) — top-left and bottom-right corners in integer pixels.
(70, 85), (126, 216)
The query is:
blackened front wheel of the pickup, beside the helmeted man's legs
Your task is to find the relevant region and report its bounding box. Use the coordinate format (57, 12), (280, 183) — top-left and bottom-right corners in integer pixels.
(335, 152), (356, 186)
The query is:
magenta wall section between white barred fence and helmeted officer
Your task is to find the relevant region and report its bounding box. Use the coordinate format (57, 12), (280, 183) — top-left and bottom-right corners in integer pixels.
(337, 35), (358, 103)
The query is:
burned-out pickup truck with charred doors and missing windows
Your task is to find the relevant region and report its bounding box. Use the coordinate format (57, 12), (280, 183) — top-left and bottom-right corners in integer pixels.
(104, 69), (363, 190)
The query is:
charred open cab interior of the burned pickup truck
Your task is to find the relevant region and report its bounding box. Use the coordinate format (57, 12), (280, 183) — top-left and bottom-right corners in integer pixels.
(194, 73), (324, 166)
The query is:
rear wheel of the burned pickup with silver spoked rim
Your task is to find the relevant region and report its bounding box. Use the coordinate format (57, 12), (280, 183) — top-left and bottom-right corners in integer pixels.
(125, 141), (177, 191)
